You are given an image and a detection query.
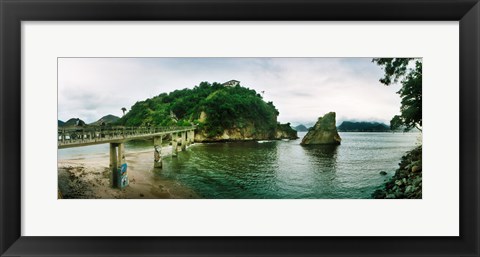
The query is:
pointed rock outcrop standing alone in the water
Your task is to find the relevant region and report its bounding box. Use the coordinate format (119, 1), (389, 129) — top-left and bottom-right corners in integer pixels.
(300, 112), (342, 145)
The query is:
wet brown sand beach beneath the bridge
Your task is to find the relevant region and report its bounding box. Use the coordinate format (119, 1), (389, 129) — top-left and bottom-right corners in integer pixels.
(58, 144), (199, 199)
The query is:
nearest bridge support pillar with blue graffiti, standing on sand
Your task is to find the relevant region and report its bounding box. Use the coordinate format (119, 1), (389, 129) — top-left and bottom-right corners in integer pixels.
(110, 143), (128, 188)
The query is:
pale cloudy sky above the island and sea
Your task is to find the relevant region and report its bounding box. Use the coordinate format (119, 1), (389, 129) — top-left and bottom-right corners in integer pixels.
(58, 58), (400, 125)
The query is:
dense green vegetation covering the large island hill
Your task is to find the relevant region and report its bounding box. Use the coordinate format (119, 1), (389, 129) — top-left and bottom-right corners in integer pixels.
(116, 82), (278, 136)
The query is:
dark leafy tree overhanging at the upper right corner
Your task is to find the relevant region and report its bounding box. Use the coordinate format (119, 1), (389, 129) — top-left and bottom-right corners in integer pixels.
(372, 58), (422, 131)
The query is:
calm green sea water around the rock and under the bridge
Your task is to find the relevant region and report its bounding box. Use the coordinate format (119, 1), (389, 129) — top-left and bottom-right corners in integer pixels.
(59, 133), (421, 199)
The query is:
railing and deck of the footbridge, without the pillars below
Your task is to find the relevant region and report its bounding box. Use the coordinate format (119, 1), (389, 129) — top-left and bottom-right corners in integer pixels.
(57, 126), (196, 148)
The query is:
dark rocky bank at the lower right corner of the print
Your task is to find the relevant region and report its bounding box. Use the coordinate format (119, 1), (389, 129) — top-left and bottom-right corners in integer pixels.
(372, 146), (422, 199)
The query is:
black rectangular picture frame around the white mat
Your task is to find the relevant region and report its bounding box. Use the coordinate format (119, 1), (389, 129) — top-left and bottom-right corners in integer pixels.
(0, 0), (480, 256)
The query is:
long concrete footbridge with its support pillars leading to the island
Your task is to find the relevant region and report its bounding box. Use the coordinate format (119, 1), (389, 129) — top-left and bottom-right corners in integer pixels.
(57, 126), (196, 188)
